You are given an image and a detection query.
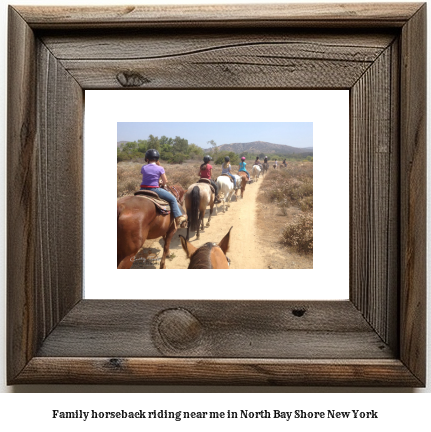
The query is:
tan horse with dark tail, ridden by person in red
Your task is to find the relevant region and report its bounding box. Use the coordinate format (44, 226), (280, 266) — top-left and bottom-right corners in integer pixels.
(184, 183), (217, 240)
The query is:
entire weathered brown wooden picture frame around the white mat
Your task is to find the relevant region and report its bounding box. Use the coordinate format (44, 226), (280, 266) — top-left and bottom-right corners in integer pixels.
(7, 3), (426, 387)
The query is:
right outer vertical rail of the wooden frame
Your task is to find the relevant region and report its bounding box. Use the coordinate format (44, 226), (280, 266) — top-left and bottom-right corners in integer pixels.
(400, 0), (427, 381)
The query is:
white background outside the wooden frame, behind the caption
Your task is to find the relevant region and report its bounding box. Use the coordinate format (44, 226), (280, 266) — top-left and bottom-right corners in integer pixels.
(0, 0), (431, 431)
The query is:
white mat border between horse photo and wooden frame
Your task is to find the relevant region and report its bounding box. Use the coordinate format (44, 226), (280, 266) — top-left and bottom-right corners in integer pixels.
(84, 90), (349, 300)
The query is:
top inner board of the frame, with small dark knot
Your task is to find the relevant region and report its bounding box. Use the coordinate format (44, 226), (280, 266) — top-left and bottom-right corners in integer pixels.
(42, 30), (395, 89)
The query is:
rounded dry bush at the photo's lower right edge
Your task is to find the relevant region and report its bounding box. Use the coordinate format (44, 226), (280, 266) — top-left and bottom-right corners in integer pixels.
(281, 212), (313, 253)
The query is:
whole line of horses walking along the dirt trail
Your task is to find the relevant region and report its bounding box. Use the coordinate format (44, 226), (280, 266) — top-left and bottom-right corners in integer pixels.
(117, 164), (268, 269)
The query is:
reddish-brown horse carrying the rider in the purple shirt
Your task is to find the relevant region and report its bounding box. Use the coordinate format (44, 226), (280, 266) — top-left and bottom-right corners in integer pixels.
(117, 185), (185, 269)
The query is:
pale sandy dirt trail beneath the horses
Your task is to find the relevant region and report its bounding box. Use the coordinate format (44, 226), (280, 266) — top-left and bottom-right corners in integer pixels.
(132, 179), (273, 269)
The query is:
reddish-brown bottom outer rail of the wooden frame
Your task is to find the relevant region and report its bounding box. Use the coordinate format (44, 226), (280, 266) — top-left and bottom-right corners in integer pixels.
(17, 357), (421, 387)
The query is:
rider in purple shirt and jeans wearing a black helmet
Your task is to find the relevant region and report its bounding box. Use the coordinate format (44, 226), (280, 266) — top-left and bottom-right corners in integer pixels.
(141, 149), (187, 228)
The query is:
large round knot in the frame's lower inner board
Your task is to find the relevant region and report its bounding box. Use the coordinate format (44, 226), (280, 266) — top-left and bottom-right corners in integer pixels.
(156, 308), (203, 350)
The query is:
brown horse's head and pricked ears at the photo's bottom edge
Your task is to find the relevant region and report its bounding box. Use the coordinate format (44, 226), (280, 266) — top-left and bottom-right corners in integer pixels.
(180, 227), (232, 269)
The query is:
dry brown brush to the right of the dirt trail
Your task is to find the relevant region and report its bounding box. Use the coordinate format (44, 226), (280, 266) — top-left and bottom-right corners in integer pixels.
(259, 161), (313, 254)
